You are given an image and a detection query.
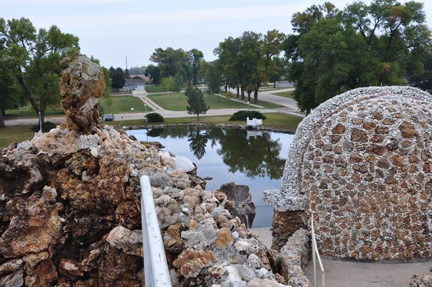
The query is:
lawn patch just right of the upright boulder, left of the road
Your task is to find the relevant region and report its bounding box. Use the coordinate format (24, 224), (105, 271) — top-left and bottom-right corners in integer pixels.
(99, 96), (153, 115)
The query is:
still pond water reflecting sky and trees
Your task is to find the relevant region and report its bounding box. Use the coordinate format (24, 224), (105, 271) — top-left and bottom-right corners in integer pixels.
(128, 127), (294, 227)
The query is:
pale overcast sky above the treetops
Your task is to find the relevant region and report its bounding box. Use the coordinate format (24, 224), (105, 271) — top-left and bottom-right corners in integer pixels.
(0, 0), (432, 68)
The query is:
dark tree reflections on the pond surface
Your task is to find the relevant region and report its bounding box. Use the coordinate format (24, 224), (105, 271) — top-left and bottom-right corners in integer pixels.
(148, 127), (285, 179)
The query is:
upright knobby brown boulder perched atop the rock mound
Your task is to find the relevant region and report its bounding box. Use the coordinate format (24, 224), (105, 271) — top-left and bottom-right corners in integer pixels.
(60, 53), (106, 134)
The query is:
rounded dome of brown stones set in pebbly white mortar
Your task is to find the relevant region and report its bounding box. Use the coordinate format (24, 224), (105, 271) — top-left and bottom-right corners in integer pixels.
(264, 87), (432, 260)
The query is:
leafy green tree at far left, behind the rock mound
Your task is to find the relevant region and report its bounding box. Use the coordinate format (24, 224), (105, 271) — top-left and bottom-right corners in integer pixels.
(0, 18), (79, 121)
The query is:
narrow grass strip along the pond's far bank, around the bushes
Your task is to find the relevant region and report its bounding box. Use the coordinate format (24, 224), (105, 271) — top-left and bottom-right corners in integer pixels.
(104, 113), (303, 130)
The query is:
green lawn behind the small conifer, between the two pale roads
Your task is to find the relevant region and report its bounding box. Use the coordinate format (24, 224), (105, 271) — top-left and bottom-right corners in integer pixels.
(148, 93), (247, 111)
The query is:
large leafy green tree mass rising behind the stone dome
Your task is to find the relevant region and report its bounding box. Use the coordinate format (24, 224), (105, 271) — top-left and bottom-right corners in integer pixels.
(283, 0), (431, 113)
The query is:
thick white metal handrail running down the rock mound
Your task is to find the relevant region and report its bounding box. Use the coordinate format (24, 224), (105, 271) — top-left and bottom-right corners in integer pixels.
(140, 175), (172, 287)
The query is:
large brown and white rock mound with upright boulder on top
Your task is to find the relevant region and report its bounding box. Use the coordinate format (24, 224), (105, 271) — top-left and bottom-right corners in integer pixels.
(0, 55), (296, 287)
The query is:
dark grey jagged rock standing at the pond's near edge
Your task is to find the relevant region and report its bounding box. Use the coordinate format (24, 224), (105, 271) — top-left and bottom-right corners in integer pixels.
(220, 182), (256, 228)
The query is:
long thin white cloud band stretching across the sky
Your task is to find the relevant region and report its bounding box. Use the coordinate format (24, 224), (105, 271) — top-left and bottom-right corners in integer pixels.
(26, 4), (302, 28)
